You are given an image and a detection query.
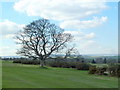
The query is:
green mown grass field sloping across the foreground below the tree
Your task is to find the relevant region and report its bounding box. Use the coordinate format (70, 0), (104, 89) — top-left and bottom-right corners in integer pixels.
(2, 61), (118, 88)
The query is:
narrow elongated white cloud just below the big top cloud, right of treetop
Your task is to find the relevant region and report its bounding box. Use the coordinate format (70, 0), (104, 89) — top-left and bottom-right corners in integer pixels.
(60, 17), (108, 29)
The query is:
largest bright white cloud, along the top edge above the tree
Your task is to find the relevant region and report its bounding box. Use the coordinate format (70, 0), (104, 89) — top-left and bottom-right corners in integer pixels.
(14, 0), (107, 21)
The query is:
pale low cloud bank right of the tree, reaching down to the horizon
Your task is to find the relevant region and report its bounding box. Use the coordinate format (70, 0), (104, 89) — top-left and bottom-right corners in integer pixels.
(64, 31), (118, 54)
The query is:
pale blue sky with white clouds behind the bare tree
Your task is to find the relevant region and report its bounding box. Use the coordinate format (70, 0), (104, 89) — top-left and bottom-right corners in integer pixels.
(0, 0), (118, 56)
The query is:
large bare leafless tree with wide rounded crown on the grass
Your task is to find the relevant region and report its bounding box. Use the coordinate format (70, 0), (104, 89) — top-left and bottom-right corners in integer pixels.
(16, 19), (72, 67)
